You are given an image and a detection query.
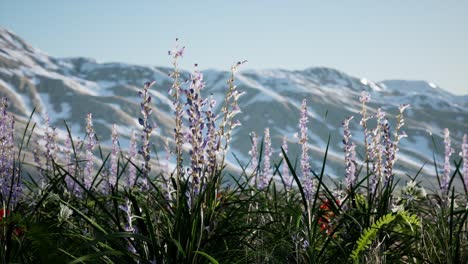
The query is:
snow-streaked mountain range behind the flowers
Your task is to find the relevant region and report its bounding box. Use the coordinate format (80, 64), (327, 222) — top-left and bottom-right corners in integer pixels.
(0, 28), (468, 177)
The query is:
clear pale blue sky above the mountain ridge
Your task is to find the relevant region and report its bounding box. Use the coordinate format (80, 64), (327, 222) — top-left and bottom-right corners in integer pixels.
(0, 0), (468, 94)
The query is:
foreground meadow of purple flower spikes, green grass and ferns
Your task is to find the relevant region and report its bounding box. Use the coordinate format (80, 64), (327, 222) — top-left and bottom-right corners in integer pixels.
(0, 42), (468, 263)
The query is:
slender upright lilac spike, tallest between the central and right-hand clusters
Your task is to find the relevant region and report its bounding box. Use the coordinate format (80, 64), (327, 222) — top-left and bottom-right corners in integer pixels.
(298, 99), (314, 201)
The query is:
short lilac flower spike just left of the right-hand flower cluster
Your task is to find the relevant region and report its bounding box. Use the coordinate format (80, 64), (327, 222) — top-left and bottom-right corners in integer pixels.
(343, 116), (357, 190)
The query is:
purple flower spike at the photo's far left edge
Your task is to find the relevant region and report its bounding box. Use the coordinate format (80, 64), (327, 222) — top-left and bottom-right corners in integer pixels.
(0, 98), (22, 208)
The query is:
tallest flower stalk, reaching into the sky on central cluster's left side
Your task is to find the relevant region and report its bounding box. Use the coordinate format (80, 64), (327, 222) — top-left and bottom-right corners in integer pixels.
(169, 39), (185, 177)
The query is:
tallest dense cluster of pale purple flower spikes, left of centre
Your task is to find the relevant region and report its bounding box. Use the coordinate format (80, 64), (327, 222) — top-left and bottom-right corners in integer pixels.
(169, 40), (244, 198)
